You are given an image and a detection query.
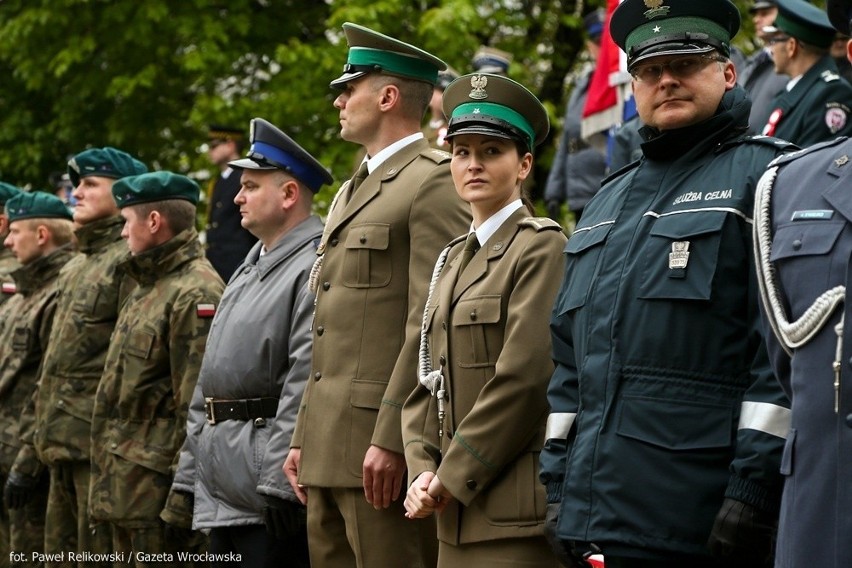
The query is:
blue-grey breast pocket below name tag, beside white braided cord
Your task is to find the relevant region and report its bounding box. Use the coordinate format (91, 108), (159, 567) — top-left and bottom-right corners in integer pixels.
(769, 221), (849, 293)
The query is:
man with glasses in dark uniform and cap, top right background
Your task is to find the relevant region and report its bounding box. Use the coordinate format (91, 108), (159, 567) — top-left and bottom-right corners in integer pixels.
(763, 0), (852, 148)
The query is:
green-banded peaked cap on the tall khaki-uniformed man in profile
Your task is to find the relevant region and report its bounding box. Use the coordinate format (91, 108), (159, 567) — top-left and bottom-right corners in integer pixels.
(329, 22), (447, 89)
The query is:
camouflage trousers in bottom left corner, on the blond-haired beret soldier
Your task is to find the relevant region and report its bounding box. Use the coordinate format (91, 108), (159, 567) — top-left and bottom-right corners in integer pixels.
(0, 475), (47, 568)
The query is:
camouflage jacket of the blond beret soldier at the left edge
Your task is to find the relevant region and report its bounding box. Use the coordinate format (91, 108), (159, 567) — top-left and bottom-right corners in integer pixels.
(0, 247), (74, 475)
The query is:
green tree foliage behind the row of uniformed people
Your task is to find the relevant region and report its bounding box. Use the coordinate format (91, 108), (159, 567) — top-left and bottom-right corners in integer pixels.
(0, 0), (772, 211)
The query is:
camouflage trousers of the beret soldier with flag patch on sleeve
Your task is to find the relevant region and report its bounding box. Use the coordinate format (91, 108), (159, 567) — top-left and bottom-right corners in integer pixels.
(112, 522), (210, 568)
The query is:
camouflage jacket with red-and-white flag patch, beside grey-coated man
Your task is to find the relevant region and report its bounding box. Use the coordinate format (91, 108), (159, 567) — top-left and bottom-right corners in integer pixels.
(89, 229), (224, 528)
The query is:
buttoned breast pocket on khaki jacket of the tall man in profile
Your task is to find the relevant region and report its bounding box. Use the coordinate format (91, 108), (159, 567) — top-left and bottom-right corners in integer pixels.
(343, 223), (391, 288)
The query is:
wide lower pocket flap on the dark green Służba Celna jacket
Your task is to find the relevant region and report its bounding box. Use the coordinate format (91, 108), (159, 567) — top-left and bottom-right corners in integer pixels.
(616, 396), (734, 450)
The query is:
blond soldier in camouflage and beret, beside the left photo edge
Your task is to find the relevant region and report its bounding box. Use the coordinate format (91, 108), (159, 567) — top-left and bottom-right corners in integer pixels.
(0, 192), (74, 566)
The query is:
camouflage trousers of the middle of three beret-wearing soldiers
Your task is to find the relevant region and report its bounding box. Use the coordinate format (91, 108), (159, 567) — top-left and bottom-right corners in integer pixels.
(44, 461), (113, 568)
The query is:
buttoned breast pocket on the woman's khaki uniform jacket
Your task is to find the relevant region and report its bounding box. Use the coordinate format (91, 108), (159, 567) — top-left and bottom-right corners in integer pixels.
(452, 296), (503, 368)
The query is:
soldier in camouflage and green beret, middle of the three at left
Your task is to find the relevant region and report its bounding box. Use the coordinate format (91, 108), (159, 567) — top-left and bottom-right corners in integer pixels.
(15, 147), (147, 567)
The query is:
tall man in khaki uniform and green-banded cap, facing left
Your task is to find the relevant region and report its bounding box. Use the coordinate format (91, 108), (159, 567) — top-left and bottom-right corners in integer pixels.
(284, 23), (470, 568)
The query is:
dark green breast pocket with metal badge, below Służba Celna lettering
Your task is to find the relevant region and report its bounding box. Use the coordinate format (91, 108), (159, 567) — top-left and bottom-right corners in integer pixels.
(639, 211), (726, 300)
